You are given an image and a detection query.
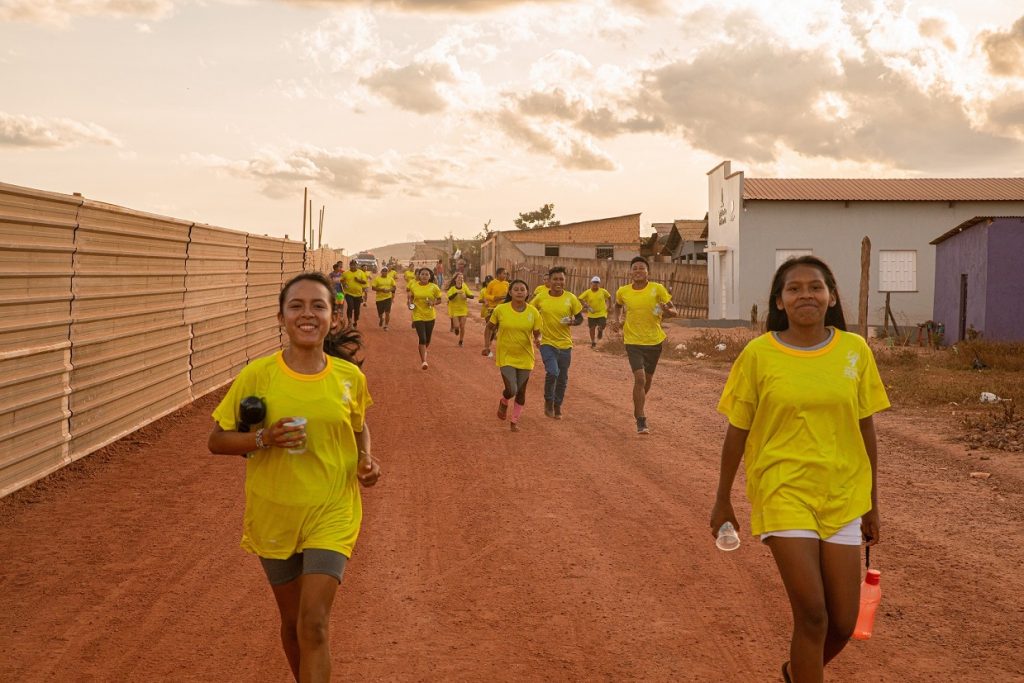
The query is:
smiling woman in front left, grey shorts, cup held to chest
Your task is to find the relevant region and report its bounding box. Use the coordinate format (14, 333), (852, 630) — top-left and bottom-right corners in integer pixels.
(208, 272), (380, 681)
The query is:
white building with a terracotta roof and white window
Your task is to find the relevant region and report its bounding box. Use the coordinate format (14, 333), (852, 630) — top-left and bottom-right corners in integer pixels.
(708, 161), (1024, 329)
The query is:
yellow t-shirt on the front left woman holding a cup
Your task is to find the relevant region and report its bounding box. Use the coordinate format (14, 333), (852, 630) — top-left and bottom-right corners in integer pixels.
(213, 351), (373, 559)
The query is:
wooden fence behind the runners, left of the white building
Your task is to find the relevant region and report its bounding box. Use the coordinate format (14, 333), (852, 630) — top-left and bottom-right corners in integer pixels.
(499, 256), (708, 319)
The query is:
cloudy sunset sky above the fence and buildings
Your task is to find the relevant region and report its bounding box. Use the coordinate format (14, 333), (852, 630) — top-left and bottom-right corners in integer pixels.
(0, 0), (1024, 251)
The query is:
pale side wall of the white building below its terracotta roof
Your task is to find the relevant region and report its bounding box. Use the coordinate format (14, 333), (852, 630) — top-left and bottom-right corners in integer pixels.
(741, 200), (1024, 327)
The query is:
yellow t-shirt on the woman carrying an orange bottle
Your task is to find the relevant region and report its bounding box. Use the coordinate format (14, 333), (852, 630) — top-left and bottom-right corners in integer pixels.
(718, 330), (889, 538)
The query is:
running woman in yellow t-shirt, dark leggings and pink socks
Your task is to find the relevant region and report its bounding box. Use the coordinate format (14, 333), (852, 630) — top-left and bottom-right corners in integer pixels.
(483, 280), (541, 431)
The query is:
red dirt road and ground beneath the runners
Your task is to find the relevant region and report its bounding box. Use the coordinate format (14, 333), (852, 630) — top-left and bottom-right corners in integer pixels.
(0, 307), (1024, 683)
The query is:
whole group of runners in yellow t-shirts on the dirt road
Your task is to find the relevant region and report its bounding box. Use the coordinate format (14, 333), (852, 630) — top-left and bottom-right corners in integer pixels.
(209, 256), (889, 683)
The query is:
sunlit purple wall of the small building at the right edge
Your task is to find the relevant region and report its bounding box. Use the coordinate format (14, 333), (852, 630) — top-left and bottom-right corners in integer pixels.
(983, 218), (1024, 341)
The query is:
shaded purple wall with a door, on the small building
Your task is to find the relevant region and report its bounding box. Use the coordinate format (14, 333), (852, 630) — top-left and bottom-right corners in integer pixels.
(932, 223), (988, 344)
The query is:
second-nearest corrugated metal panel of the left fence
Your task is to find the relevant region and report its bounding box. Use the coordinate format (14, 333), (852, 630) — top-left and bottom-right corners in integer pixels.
(71, 201), (191, 459)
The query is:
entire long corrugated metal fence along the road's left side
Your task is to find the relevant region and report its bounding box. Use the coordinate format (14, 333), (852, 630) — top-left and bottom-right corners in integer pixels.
(0, 183), (305, 497)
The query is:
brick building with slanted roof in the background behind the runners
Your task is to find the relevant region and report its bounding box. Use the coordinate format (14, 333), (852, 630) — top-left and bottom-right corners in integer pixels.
(480, 213), (640, 274)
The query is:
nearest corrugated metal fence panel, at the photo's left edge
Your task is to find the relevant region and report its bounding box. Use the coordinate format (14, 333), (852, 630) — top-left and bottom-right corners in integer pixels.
(0, 183), (82, 497)
